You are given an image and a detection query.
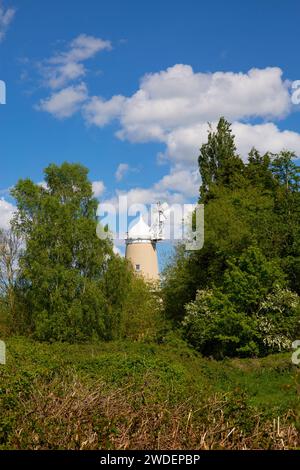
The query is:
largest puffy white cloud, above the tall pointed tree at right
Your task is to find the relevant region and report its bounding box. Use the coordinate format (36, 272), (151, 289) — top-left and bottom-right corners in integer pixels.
(87, 64), (291, 142)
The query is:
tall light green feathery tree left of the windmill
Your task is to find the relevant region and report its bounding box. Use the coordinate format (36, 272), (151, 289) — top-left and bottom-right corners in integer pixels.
(12, 163), (119, 341)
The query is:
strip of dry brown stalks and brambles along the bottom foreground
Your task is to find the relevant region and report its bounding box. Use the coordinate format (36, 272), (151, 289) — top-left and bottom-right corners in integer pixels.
(9, 373), (300, 450)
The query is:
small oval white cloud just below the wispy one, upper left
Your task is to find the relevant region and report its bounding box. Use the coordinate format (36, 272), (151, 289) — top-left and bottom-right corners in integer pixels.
(38, 83), (88, 119)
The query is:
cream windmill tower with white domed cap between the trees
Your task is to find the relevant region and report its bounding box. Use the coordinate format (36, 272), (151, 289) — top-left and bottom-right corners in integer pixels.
(125, 203), (164, 281)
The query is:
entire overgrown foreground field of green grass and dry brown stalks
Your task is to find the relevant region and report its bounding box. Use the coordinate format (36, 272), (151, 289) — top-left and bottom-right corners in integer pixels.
(0, 335), (300, 449)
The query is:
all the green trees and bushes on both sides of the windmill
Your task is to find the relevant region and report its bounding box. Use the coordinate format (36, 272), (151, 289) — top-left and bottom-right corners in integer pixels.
(0, 118), (300, 358)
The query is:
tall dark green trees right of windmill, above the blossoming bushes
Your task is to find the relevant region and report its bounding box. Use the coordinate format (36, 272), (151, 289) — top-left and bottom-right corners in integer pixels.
(163, 118), (300, 351)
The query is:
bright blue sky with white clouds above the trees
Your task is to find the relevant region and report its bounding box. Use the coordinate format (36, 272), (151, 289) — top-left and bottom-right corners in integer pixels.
(0, 0), (300, 252)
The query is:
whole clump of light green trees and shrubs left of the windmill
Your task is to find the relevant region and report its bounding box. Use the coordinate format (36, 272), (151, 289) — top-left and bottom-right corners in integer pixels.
(0, 163), (159, 342)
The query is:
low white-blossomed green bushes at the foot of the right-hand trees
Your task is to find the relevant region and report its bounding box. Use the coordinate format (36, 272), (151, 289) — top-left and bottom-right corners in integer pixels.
(182, 287), (300, 359)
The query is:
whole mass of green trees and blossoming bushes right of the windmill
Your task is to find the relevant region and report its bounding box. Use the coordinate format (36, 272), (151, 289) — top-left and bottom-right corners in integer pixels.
(163, 118), (300, 358)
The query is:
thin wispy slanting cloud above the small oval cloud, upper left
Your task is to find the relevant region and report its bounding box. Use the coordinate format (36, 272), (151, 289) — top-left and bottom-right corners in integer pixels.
(41, 34), (112, 89)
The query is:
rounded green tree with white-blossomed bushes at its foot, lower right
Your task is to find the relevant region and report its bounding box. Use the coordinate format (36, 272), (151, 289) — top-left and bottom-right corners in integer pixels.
(182, 247), (300, 359)
